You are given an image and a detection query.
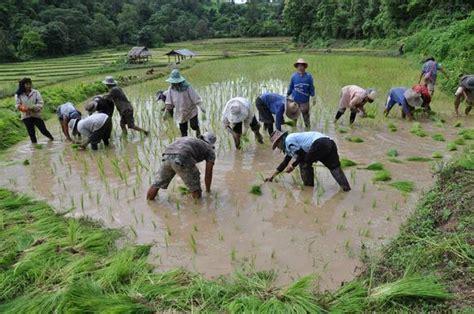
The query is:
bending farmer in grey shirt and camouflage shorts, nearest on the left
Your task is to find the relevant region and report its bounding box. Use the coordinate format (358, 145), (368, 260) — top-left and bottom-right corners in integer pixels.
(146, 133), (216, 200)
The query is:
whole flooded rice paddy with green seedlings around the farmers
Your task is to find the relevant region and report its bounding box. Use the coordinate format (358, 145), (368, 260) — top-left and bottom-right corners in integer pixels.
(0, 49), (473, 290)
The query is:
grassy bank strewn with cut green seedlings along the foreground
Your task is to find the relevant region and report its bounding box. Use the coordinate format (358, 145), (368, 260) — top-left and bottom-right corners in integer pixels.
(0, 151), (474, 313)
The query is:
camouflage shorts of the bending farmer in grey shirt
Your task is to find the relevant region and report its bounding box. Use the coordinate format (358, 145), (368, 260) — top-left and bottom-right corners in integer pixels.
(153, 154), (201, 192)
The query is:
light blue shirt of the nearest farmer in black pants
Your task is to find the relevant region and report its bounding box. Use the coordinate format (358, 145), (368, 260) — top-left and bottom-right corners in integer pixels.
(277, 132), (329, 172)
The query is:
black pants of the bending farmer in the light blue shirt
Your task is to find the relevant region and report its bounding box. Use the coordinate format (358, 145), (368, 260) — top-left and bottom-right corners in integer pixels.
(300, 137), (341, 186)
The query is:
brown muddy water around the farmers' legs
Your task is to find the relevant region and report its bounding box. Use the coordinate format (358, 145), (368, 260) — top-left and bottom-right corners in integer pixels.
(0, 80), (472, 289)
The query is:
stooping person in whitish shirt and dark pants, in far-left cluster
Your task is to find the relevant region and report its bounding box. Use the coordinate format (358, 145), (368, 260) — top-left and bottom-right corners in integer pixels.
(69, 112), (112, 150)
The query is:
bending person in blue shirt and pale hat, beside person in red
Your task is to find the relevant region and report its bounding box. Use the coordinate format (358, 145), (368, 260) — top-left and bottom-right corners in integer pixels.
(384, 87), (423, 121)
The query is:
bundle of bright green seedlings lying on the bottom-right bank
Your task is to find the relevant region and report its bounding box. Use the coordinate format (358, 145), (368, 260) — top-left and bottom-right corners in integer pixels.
(368, 275), (451, 304)
